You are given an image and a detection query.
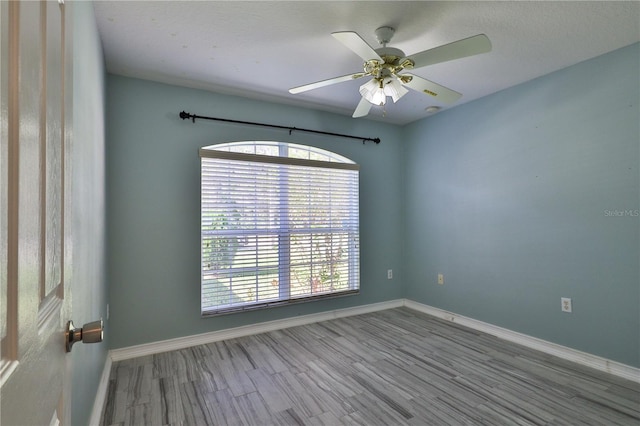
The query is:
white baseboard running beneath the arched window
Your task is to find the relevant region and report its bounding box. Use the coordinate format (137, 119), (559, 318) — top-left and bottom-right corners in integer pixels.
(109, 299), (404, 361)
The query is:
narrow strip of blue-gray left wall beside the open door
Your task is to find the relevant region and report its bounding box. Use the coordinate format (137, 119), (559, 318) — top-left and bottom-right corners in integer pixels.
(69, 2), (109, 425)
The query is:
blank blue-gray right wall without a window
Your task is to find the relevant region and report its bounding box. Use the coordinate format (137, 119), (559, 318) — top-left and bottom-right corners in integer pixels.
(403, 44), (640, 367)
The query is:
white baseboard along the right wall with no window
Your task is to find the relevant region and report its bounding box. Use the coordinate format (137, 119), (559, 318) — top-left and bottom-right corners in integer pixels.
(404, 300), (640, 383)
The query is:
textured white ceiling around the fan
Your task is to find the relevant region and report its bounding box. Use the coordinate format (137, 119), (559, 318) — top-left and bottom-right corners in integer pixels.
(94, 1), (640, 124)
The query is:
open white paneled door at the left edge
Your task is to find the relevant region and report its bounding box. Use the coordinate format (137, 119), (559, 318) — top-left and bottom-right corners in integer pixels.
(0, 1), (72, 426)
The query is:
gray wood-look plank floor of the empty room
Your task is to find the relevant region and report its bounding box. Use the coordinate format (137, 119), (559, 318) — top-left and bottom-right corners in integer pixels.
(102, 308), (640, 425)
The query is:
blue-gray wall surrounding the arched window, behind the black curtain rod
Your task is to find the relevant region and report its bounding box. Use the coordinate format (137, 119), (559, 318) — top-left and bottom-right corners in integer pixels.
(107, 75), (404, 348)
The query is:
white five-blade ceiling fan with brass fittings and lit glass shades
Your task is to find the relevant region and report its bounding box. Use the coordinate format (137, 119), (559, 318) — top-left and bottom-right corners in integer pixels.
(289, 27), (491, 118)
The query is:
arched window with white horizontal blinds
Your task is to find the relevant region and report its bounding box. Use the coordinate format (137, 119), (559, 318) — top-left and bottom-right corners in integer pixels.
(200, 141), (360, 315)
